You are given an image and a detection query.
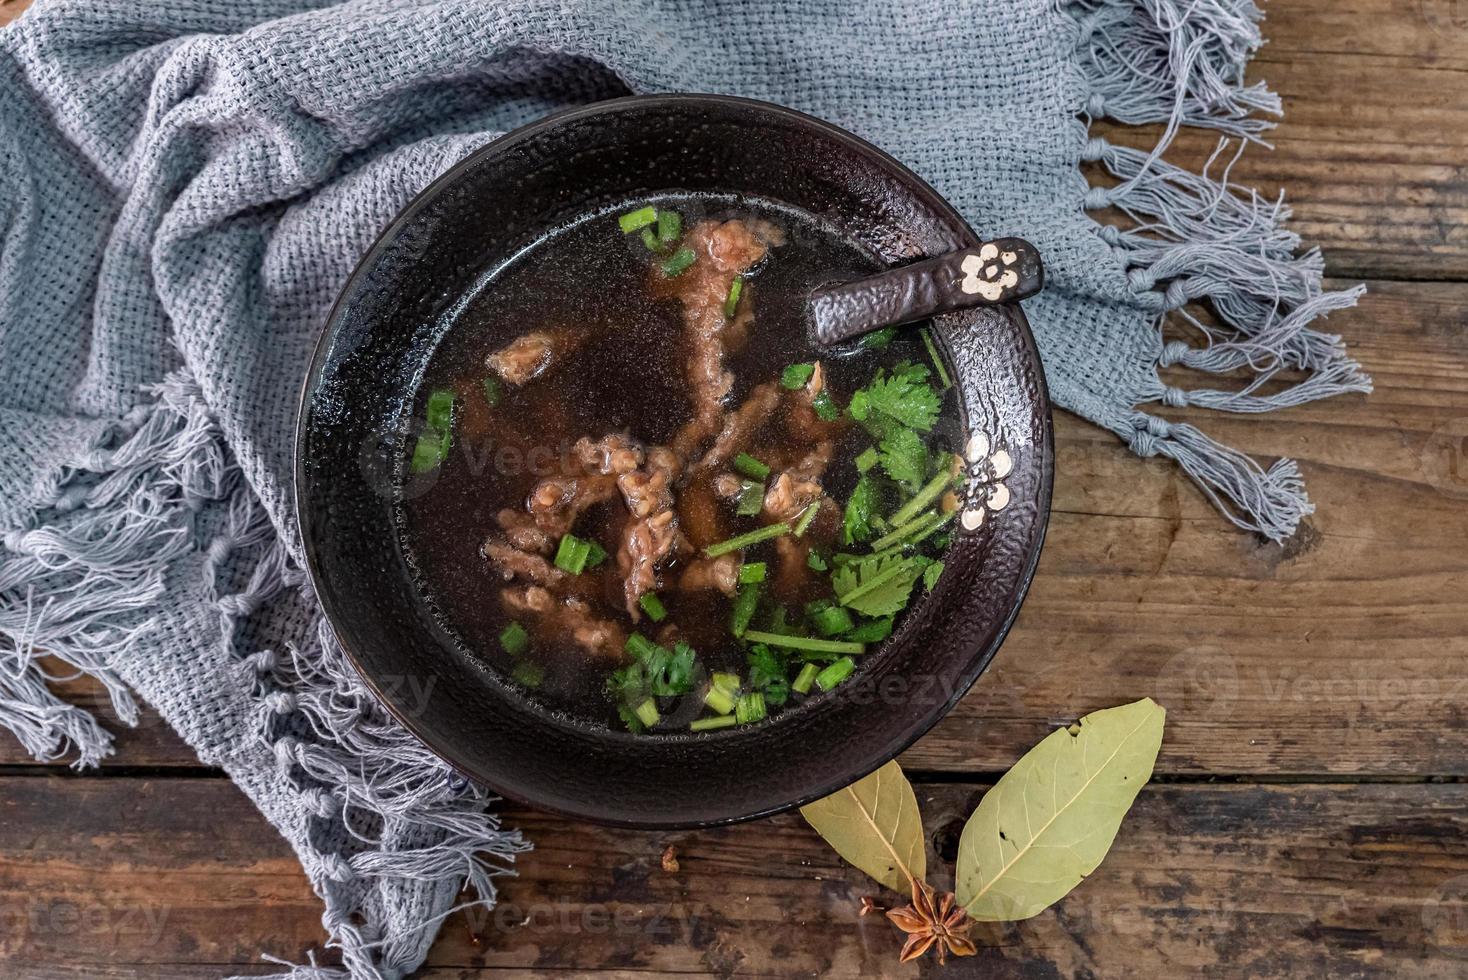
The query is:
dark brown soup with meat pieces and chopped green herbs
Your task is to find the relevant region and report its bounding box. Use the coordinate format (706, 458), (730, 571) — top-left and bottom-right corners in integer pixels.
(398, 197), (962, 732)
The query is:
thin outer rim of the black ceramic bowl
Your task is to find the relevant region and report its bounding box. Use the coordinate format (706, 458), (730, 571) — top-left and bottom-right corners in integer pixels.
(291, 92), (1055, 830)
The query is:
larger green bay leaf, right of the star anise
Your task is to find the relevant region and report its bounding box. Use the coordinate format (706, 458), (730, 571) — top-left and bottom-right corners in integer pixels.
(957, 698), (1167, 921)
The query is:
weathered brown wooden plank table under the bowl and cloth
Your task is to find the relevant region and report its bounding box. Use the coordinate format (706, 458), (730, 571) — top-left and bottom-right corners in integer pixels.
(0, 0), (1468, 979)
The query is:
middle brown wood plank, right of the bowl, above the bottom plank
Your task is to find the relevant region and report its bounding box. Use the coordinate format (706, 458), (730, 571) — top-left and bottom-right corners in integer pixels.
(0, 283), (1468, 775)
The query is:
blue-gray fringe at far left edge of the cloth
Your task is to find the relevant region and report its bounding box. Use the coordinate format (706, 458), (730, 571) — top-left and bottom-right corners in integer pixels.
(0, 371), (225, 767)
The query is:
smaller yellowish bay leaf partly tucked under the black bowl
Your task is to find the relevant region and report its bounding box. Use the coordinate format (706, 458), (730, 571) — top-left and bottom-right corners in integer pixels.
(800, 761), (928, 892)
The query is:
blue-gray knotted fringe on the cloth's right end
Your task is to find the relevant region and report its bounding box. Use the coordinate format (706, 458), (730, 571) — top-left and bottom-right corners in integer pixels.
(1061, 0), (1371, 541)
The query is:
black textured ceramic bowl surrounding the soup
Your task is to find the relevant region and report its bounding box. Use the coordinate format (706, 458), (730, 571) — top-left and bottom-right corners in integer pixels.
(295, 95), (1053, 827)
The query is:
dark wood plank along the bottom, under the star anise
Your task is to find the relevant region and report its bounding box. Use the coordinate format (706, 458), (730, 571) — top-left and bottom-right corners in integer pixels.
(0, 778), (1468, 977)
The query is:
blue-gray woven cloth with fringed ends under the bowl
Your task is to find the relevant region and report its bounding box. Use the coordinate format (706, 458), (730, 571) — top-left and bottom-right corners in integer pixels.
(0, 0), (1368, 977)
